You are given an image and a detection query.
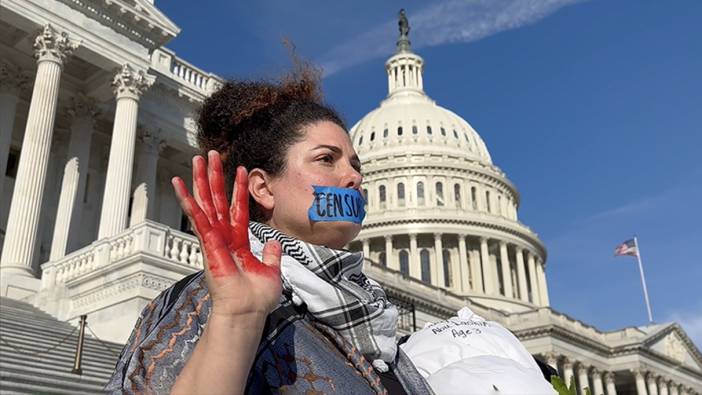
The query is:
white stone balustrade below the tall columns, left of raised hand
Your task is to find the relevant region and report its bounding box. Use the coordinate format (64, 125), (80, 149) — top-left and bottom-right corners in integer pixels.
(42, 221), (203, 288)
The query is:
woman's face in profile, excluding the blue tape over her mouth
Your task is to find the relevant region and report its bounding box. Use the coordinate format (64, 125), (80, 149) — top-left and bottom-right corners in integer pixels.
(268, 121), (363, 249)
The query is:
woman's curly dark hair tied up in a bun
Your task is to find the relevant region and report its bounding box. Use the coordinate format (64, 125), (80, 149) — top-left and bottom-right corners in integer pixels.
(197, 65), (346, 221)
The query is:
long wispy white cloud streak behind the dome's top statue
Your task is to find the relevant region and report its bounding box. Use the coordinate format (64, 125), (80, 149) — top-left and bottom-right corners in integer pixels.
(317, 0), (585, 75)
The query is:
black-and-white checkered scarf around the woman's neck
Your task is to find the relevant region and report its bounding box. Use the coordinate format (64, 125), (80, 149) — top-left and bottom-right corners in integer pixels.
(249, 222), (398, 370)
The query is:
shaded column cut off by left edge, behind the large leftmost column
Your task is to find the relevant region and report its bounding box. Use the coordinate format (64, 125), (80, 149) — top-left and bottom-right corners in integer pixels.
(0, 60), (29, 202)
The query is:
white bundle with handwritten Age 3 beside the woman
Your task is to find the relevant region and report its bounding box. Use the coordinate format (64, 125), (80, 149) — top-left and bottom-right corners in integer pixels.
(401, 307), (556, 395)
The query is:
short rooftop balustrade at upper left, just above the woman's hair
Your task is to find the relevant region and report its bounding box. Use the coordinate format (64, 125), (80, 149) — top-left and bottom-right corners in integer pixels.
(151, 47), (222, 97)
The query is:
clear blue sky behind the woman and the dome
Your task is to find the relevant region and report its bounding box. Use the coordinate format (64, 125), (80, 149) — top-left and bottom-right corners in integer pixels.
(156, 0), (702, 348)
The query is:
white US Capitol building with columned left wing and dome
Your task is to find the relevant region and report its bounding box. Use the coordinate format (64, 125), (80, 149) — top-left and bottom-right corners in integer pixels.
(0, 0), (702, 395)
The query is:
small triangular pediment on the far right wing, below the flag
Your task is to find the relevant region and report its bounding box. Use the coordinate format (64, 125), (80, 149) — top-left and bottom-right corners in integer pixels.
(644, 324), (702, 372)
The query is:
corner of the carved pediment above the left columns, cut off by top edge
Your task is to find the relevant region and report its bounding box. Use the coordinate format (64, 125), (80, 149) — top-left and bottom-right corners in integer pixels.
(59, 0), (180, 50)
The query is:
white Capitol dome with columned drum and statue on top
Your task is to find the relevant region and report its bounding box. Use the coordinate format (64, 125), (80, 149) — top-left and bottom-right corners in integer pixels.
(349, 13), (549, 311)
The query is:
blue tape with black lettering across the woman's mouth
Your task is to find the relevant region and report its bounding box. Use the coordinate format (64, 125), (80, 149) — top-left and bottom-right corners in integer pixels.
(307, 185), (366, 224)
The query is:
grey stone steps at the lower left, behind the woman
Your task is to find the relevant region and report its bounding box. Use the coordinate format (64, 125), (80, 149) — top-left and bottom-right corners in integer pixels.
(0, 297), (123, 394)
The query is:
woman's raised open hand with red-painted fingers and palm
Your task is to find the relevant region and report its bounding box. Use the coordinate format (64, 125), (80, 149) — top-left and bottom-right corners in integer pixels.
(172, 151), (281, 318)
